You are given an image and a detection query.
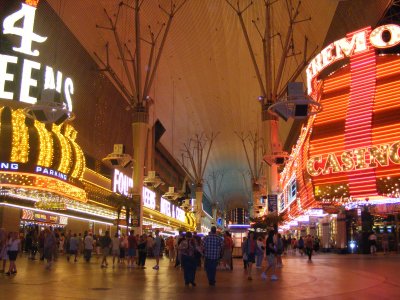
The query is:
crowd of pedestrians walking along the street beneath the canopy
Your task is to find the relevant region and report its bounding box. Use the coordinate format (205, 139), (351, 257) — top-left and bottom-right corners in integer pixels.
(0, 226), (324, 286)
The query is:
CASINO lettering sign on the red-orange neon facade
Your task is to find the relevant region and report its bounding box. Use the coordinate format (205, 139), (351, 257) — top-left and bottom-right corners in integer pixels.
(307, 141), (400, 176)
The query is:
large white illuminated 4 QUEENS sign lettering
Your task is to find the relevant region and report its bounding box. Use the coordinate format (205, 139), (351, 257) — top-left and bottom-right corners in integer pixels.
(0, 3), (74, 111)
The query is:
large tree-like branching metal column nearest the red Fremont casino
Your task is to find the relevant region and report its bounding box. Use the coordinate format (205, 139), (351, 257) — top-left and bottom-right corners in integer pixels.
(225, 0), (316, 217)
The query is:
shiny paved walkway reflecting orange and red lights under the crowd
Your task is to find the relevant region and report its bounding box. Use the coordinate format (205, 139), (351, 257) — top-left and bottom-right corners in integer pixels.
(0, 254), (400, 300)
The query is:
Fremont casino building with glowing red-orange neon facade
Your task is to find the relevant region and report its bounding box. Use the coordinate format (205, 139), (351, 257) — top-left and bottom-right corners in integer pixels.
(278, 25), (400, 252)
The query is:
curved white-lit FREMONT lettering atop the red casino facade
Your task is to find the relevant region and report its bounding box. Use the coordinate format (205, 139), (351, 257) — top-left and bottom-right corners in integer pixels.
(306, 24), (400, 94)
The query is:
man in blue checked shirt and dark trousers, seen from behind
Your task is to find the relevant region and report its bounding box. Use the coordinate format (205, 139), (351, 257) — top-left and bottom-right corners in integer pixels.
(203, 226), (223, 286)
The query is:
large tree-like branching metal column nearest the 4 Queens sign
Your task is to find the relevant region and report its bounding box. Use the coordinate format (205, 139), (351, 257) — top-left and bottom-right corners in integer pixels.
(94, 0), (187, 232)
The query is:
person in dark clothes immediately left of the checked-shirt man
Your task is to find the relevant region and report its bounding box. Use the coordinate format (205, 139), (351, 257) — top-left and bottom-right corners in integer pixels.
(178, 232), (196, 286)
